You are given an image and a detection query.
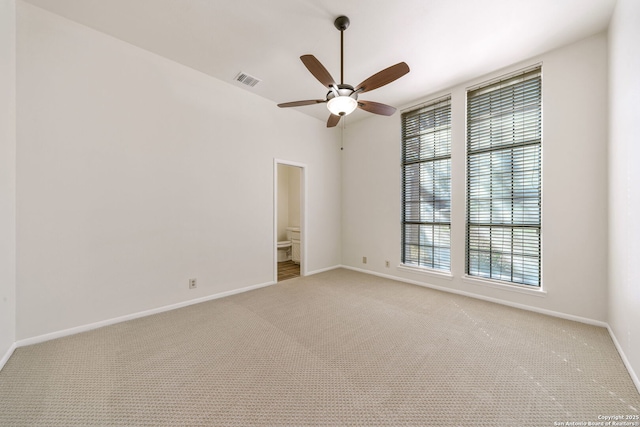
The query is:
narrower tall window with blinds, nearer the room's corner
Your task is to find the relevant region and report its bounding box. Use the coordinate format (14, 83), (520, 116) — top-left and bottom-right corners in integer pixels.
(402, 98), (451, 271)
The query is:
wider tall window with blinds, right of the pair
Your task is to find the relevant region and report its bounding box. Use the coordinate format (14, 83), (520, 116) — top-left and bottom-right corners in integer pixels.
(466, 67), (542, 287)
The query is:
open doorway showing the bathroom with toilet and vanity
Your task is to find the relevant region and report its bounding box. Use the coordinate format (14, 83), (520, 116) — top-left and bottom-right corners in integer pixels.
(274, 159), (306, 282)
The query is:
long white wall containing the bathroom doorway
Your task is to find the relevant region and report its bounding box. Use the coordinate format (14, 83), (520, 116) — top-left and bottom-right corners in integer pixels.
(17, 2), (341, 340)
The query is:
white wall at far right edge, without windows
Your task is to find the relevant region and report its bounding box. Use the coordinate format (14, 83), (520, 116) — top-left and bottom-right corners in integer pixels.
(609, 0), (640, 390)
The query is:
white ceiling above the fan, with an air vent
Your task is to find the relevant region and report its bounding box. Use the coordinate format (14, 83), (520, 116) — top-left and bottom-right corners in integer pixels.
(25, 0), (615, 121)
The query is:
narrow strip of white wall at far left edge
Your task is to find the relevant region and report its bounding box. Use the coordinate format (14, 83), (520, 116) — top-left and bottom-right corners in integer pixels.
(0, 0), (16, 362)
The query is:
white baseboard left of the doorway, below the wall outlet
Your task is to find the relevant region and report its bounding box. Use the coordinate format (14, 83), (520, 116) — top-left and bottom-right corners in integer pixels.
(14, 282), (276, 348)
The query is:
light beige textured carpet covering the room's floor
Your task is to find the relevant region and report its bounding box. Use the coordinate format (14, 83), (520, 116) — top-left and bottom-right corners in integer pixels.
(0, 269), (640, 427)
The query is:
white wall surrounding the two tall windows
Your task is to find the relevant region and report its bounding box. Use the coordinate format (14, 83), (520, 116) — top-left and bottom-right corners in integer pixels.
(342, 33), (607, 322)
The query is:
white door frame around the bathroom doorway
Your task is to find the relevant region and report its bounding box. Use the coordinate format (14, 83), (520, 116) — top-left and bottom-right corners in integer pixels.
(271, 158), (308, 283)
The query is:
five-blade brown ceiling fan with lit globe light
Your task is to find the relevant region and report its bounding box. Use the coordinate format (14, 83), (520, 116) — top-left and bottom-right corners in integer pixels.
(278, 16), (409, 128)
